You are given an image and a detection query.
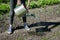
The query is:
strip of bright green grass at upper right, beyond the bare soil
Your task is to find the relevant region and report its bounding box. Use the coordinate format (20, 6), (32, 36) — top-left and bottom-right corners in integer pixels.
(30, 0), (60, 8)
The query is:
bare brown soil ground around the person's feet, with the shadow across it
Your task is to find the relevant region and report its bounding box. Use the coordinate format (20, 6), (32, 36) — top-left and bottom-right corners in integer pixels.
(0, 4), (60, 40)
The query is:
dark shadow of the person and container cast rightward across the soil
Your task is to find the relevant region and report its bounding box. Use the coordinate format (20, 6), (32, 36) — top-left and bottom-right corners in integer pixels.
(13, 22), (60, 32)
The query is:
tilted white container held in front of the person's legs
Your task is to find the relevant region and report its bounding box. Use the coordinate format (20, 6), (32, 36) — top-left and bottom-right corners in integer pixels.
(14, 4), (27, 16)
